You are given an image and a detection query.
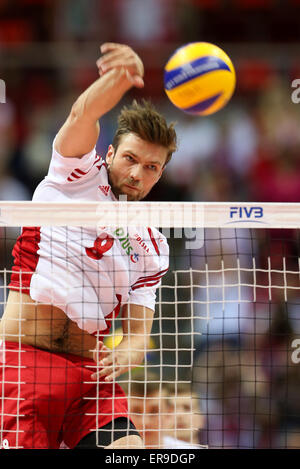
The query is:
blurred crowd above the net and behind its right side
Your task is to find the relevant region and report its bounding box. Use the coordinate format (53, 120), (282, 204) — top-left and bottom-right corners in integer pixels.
(0, 0), (300, 448)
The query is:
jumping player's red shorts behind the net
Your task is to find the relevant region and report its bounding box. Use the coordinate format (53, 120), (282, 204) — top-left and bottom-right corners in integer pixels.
(0, 342), (128, 449)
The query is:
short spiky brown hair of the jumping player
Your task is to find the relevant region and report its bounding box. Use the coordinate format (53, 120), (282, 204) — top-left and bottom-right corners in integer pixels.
(112, 99), (177, 165)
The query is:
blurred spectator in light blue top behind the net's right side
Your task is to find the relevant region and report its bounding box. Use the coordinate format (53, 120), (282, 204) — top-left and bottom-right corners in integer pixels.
(191, 228), (258, 350)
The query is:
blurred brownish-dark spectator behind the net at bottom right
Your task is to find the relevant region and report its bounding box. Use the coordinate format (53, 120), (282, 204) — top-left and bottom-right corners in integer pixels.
(194, 338), (279, 449)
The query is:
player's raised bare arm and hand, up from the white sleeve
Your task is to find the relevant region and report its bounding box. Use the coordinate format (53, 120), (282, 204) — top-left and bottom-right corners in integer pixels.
(55, 43), (144, 158)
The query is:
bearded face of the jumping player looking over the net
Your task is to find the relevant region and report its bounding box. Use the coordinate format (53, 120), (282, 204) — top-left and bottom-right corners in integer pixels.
(106, 133), (167, 200)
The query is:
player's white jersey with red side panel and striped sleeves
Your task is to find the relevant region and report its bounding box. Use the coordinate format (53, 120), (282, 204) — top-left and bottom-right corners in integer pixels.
(10, 137), (169, 334)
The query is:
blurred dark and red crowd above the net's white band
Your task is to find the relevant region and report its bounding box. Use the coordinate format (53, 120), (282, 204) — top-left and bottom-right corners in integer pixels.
(0, 0), (300, 202)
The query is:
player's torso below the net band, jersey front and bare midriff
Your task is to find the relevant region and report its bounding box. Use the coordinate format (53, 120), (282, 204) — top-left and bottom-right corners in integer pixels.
(0, 219), (156, 358)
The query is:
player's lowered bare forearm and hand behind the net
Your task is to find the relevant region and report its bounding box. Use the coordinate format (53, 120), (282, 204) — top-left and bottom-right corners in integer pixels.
(92, 304), (154, 381)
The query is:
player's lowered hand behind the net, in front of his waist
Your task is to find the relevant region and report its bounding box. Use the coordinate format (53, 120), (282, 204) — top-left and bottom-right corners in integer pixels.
(91, 341), (144, 382)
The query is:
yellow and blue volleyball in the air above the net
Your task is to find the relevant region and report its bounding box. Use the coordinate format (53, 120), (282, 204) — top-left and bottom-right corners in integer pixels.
(164, 42), (236, 116)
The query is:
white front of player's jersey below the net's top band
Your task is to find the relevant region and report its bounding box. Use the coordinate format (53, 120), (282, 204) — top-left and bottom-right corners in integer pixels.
(30, 222), (156, 326)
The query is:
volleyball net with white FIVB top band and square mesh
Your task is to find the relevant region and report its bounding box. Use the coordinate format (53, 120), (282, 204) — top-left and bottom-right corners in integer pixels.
(0, 201), (300, 449)
